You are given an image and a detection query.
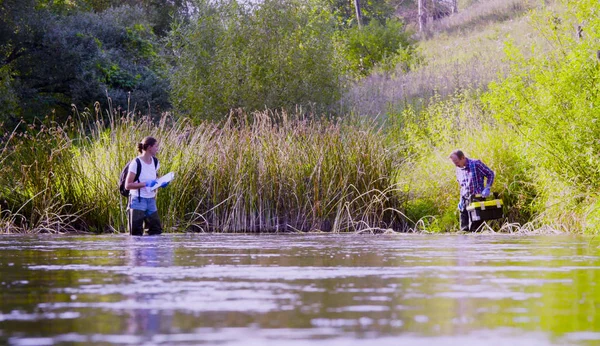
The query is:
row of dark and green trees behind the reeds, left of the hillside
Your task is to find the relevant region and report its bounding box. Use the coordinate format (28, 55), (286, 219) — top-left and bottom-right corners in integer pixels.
(0, 0), (414, 124)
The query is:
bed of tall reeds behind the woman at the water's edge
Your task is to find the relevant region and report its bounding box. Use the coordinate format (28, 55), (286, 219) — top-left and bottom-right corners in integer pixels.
(2, 112), (407, 232)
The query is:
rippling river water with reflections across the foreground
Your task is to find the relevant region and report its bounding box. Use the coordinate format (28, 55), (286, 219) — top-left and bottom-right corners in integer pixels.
(0, 234), (600, 346)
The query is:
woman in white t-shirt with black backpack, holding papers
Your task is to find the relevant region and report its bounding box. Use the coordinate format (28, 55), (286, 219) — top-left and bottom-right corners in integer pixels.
(125, 137), (169, 235)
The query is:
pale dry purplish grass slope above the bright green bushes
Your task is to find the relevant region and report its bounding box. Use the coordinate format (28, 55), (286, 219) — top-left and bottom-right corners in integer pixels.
(344, 0), (558, 115)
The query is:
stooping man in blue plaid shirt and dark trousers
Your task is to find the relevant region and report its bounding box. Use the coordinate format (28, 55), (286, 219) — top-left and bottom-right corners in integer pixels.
(450, 150), (495, 232)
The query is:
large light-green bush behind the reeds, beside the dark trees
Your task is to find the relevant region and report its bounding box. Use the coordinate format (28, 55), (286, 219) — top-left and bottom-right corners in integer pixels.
(169, 0), (342, 119)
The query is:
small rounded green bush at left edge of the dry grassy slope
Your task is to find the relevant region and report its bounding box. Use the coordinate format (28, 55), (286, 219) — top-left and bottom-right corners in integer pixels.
(340, 19), (416, 76)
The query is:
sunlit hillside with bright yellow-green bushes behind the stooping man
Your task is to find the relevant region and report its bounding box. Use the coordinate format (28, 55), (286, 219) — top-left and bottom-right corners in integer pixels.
(370, 0), (600, 232)
